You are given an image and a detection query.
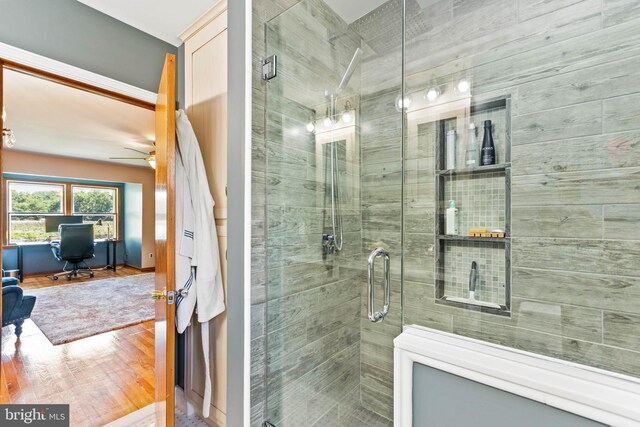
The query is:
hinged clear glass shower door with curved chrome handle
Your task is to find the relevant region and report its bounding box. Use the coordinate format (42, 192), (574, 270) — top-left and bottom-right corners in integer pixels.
(264, 0), (402, 427)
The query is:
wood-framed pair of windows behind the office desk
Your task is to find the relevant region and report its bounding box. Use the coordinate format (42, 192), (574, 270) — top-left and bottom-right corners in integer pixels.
(6, 181), (119, 244)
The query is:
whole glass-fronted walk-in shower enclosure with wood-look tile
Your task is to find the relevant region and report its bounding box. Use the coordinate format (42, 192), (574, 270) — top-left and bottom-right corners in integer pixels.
(252, 0), (640, 427)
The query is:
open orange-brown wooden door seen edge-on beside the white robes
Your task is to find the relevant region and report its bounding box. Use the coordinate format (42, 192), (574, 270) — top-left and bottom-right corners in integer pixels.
(154, 54), (176, 426)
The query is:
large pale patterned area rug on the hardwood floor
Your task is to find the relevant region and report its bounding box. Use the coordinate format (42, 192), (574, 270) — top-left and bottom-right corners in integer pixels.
(25, 273), (155, 345)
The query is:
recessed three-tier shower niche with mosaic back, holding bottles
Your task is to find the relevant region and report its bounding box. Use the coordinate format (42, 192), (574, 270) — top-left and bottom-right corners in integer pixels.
(435, 96), (511, 316)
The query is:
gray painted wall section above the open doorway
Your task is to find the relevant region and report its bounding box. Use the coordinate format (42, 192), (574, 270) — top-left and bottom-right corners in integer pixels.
(0, 0), (177, 92)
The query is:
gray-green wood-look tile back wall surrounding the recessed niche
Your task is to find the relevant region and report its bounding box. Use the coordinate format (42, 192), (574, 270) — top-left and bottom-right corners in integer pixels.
(361, 0), (640, 417)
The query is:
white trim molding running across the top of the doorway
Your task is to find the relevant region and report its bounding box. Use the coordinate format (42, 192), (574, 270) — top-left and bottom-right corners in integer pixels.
(0, 42), (156, 104)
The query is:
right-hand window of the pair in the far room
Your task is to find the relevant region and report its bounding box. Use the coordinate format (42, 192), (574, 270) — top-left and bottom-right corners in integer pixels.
(71, 185), (118, 239)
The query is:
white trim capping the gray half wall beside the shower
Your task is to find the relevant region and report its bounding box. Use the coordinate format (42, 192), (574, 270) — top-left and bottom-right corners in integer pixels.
(394, 325), (640, 426)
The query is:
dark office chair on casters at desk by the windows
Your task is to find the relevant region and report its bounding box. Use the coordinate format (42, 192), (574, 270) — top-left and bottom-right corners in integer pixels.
(51, 224), (94, 280)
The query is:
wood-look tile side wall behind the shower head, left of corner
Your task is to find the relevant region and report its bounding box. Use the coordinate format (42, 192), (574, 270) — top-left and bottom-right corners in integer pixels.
(252, 0), (363, 426)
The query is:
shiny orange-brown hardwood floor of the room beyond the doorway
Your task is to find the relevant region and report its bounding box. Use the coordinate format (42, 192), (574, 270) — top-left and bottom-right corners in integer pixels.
(0, 267), (154, 426)
